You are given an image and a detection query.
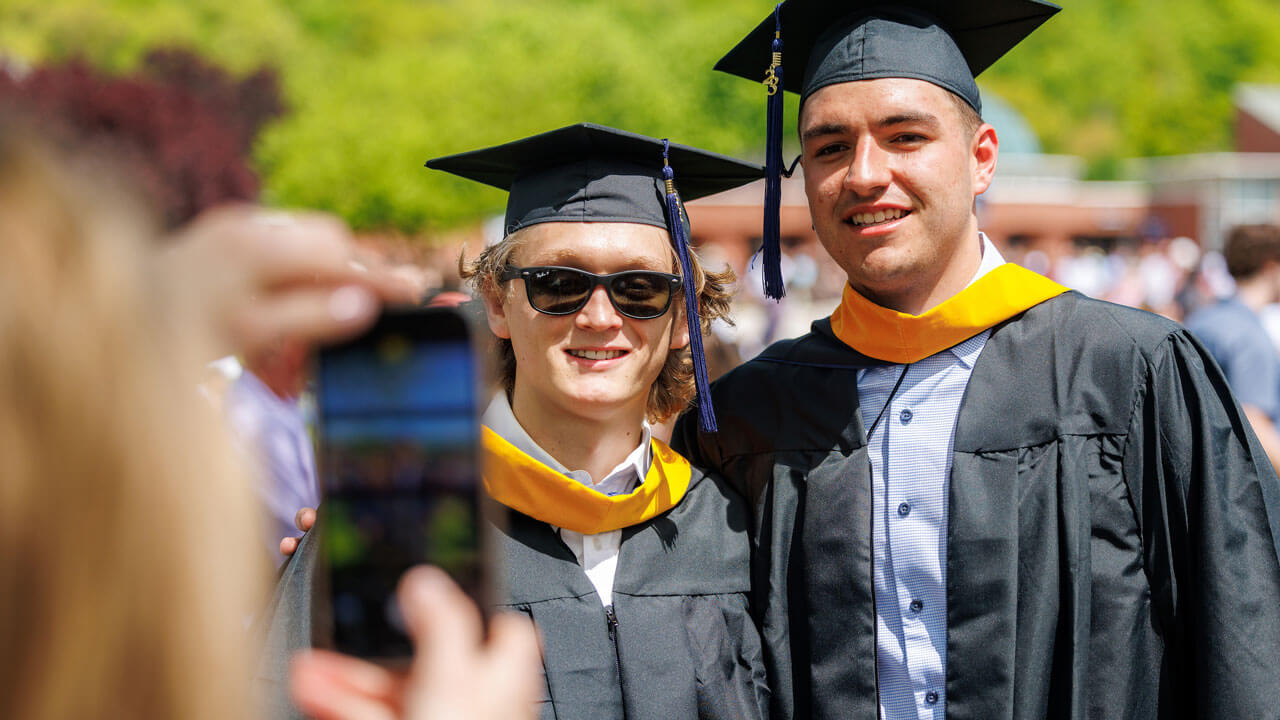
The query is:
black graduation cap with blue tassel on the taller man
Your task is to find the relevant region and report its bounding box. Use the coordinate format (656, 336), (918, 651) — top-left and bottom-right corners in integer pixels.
(716, 0), (1060, 297)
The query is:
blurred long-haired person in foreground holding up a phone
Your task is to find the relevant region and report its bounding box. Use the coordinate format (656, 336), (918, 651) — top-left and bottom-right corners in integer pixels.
(0, 122), (536, 720)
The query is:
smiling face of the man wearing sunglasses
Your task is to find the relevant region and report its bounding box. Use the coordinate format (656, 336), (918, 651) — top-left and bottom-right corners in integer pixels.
(485, 223), (689, 427)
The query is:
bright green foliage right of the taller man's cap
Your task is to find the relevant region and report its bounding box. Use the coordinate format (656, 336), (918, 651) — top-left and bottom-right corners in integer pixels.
(982, 0), (1280, 177)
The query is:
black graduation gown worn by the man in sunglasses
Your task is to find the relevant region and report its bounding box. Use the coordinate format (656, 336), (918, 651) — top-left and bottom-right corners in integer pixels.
(260, 461), (769, 720)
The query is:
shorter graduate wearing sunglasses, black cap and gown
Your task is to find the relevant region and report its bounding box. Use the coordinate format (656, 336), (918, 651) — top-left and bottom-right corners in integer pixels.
(428, 124), (768, 720)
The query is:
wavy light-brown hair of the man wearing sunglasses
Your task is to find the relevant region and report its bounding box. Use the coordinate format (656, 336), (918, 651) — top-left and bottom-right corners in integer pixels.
(458, 225), (735, 423)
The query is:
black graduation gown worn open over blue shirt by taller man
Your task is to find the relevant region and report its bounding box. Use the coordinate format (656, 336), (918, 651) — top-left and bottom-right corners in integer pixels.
(675, 292), (1280, 720)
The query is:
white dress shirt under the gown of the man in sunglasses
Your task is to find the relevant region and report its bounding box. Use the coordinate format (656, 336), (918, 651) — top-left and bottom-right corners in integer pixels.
(484, 392), (653, 607)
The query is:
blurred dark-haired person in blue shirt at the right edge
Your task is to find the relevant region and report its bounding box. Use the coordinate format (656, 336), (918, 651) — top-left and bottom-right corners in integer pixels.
(1187, 224), (1280, 468)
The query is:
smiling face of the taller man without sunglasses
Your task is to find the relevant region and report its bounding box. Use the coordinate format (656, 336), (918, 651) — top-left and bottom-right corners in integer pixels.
(800, 78), (997, 314)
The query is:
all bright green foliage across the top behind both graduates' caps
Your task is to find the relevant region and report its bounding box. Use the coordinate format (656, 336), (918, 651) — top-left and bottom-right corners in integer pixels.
(0, 0), (1280, 224)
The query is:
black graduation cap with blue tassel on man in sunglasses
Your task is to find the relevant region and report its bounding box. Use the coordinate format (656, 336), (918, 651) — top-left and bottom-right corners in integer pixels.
(426, 123), (764, 432)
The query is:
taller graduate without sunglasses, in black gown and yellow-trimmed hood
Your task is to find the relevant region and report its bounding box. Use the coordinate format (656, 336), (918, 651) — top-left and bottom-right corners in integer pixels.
(676, 0), (1280, 720)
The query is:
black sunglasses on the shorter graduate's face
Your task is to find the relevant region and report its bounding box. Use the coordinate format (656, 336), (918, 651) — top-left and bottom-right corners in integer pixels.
(500, 265), (681, 320)
